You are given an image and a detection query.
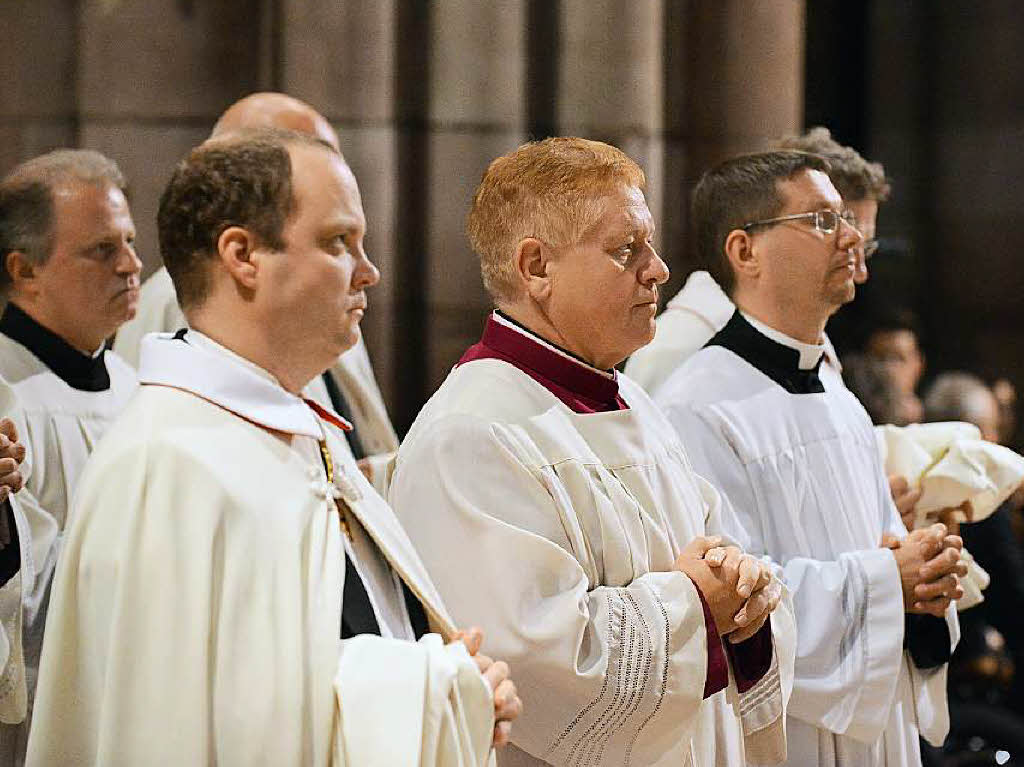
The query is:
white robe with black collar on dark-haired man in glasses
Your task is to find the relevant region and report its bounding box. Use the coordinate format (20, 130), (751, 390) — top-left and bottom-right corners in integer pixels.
(654, 311), (958, 767)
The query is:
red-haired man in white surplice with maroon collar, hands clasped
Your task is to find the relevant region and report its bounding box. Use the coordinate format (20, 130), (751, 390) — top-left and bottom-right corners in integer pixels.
(389, 138), (794, 765)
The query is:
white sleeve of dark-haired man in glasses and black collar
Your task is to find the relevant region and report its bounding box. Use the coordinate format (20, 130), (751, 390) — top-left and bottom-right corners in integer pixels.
(666, 406), (905, 742)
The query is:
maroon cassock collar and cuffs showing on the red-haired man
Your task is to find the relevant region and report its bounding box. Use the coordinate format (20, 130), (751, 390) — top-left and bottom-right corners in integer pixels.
(459, 311), (772, 697)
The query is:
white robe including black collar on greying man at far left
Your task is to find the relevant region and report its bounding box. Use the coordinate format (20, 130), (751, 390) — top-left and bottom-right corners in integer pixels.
(0, 303), (137, 764)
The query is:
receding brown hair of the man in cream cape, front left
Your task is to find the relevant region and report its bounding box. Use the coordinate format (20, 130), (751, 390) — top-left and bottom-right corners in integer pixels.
(157, 128), (340, 308)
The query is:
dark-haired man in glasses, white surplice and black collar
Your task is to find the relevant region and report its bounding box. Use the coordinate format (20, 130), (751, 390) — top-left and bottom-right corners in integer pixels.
(655, 152), (965, 767)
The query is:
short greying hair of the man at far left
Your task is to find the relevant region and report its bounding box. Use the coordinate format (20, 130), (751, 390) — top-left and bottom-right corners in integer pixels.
(0, 150), (125, 295)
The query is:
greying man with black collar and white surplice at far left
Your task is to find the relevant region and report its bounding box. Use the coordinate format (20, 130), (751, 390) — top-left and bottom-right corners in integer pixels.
(0, 150), (141, 764)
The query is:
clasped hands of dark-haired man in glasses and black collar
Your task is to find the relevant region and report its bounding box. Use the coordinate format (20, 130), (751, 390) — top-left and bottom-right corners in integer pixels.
(892, 523), (967, 617)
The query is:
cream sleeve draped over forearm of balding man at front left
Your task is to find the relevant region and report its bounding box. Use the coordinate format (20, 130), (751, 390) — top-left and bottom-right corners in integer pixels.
(334, 634), (495, 767)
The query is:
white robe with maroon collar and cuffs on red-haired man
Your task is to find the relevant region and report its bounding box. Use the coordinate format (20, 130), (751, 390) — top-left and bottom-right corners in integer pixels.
(389, 312), (795, 766)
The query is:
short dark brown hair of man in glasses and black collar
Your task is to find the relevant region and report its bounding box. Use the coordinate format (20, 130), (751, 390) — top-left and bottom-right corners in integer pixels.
(690, 150), (829, 295)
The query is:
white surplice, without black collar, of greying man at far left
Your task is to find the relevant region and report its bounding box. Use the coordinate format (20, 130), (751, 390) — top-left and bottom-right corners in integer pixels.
(0, 334), (137, 765)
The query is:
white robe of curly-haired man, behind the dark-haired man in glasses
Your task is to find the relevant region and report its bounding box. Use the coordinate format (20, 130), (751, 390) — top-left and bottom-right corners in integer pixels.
(626, 271), (843, 394)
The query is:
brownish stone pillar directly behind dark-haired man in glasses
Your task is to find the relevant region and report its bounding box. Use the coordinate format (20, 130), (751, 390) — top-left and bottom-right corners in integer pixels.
(660, 0), (804, 296)
